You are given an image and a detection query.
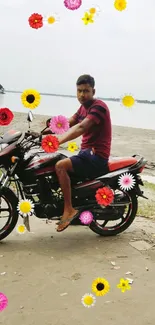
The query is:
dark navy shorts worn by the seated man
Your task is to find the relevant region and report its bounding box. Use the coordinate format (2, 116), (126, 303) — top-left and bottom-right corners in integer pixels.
(70, 149), (109, 178)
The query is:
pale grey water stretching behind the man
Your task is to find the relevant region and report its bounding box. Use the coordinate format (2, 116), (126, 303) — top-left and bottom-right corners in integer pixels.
(0, 93), (155, 130)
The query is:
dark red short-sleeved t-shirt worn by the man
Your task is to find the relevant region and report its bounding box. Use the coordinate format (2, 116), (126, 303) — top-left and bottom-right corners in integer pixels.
(73, 99), (112, 159)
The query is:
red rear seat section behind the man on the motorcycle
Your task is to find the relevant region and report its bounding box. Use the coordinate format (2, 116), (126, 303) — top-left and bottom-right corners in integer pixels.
(108, 157), (138, 172)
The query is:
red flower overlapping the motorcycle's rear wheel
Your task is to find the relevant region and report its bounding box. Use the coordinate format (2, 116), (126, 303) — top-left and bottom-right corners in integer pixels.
(95, 187), (114, 206)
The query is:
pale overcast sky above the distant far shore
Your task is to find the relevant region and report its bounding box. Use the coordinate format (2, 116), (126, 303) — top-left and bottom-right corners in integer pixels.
(0, 0), (155, 100)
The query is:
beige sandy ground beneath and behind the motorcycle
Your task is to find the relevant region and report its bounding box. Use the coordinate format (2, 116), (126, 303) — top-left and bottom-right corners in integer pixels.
(0, 113), (155, 325)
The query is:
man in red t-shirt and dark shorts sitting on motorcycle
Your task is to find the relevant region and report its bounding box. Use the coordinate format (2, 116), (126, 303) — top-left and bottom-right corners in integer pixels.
(32, 75), (112, 232)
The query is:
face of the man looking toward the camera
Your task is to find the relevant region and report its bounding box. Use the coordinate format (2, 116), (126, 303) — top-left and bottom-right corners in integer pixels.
(77, 84), (95, 105)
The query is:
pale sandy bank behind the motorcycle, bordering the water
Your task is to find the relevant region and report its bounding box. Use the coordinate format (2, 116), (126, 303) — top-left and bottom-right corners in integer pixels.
(0, 111), (155, 176)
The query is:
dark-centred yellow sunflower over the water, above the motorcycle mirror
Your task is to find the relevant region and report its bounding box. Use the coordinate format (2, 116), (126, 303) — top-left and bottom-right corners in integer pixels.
(21, 89), (41, 109)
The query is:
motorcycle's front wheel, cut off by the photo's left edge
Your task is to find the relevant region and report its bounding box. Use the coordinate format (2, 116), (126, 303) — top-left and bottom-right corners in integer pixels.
(0, 187), (18, 240)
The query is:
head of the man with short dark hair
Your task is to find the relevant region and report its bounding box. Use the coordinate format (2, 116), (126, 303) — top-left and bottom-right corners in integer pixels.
(76, 74), (95, 105)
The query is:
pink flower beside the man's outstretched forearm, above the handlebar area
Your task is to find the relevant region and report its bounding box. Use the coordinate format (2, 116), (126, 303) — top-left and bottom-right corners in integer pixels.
(49, 115), (69, 134)
